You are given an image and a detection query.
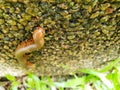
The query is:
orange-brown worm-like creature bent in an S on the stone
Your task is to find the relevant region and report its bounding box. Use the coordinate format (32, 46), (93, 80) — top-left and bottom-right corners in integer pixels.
(15, 27), (45, 67)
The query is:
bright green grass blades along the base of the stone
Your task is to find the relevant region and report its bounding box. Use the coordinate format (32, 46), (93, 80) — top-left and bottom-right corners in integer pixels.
(6, 58), (120, 90)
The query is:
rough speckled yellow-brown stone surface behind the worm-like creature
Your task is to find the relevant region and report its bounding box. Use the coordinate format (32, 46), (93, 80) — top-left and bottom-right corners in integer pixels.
(0, 0), (120, 76)
